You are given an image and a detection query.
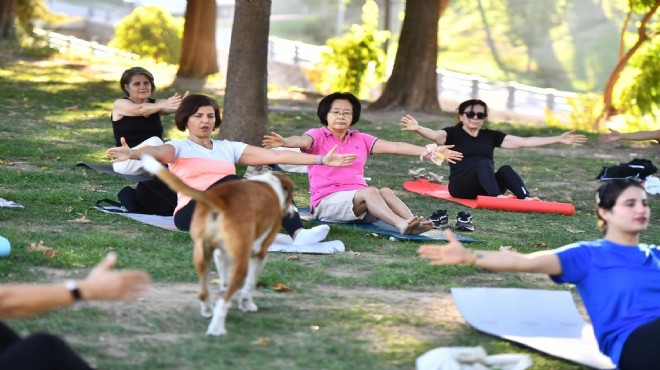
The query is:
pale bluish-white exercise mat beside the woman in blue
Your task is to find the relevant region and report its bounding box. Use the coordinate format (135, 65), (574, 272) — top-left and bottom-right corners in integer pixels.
(451, 288), (615, 369)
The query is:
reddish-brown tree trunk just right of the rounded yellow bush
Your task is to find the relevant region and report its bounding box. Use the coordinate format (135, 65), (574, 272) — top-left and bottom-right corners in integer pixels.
(176, 0), (219, 78)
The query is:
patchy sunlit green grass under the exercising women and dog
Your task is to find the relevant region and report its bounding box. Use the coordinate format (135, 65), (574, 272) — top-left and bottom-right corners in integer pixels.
(0, 53), (660, 369)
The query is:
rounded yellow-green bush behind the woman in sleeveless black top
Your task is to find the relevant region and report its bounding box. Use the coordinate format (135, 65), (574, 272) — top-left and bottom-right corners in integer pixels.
(109, 5), (183, 64)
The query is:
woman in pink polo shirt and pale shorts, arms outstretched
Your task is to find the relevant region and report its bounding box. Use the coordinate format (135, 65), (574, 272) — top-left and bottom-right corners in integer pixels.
(263, 93), (462, 234)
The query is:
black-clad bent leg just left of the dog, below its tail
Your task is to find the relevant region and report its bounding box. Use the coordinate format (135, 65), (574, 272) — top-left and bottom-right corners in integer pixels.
(117, 178), (177, 216)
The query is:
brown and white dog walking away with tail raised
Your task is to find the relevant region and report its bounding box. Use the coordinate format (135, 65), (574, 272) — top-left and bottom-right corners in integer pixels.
(142, 155), (295, 336)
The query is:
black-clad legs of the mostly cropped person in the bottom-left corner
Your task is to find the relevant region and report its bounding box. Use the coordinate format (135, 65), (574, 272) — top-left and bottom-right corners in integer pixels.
(0, 322), (92, 370)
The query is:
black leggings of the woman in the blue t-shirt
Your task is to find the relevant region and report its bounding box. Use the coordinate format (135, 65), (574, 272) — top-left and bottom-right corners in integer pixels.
(619, 319), (660, 370)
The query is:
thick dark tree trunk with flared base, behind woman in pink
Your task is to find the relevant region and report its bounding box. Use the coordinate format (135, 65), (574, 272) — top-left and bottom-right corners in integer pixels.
(369, 0), (450, 113)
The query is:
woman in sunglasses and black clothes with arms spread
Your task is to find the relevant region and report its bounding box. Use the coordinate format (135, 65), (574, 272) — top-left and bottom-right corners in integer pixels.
(400, 99), (587, 200)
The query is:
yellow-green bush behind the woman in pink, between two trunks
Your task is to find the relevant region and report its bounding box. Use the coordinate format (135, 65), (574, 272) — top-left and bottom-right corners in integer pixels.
(317, 0), (390, 99)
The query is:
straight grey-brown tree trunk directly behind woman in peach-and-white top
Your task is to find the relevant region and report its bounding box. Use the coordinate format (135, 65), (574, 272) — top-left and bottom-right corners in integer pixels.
(220, 0), (271, 146)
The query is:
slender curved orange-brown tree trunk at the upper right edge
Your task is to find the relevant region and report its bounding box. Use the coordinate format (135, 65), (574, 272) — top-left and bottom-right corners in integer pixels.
(594, 1), (660, 125)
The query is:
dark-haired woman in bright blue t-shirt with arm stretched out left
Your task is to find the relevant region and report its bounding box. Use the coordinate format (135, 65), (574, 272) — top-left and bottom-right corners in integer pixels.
(419, 180), (660, 370)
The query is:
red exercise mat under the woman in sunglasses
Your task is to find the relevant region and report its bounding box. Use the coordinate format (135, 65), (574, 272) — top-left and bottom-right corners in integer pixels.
(403, 179), (575, 216)
